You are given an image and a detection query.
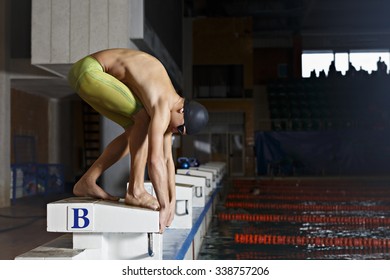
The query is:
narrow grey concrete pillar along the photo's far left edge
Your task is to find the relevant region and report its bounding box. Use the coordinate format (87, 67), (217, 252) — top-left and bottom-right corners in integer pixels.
(0, 0), (11, 207)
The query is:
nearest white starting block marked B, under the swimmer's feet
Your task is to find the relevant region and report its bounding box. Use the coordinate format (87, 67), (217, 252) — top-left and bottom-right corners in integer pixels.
(17, 197), (163, 260)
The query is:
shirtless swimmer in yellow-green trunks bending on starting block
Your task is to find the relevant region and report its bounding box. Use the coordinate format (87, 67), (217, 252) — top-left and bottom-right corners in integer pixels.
(68, 49), (208, 232)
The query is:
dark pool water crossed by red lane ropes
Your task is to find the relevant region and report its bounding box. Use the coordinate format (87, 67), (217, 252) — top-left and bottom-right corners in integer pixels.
(198, 179), (390, 260)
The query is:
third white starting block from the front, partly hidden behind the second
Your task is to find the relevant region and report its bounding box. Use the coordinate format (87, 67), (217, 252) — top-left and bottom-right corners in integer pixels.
(175, 174), (206, 207)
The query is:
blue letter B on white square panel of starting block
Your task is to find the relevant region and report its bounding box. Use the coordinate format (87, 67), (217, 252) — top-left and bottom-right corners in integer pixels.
(67, 205), (93, 231)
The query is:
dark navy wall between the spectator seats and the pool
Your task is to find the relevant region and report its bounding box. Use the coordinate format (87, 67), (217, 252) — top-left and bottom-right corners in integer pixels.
(255, 129), (390, 176)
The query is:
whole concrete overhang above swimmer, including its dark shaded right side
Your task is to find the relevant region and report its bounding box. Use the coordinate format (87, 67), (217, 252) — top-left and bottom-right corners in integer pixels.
(31, 0), (182, 89)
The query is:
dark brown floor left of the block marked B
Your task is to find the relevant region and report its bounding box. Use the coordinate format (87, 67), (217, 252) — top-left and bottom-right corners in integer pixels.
(0, 194), (70, 260)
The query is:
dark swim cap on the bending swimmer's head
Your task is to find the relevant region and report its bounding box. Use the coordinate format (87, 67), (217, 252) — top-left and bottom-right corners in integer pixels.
(184, 99), (209, 135)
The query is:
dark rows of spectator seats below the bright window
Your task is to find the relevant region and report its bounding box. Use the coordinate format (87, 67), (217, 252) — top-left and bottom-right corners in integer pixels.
(267, 76), (390, 131)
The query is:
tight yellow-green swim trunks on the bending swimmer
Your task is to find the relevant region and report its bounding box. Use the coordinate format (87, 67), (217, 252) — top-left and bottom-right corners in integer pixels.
(68, 56), (143, 128)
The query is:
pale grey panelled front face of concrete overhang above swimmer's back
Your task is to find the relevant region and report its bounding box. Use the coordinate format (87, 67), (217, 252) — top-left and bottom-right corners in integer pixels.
(31, 0), (134, 65)
